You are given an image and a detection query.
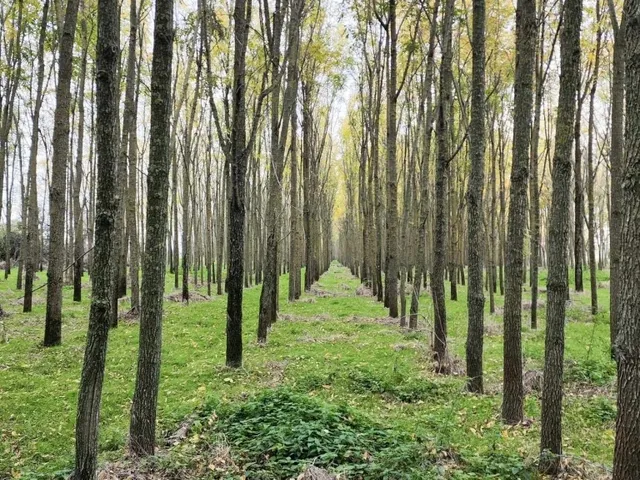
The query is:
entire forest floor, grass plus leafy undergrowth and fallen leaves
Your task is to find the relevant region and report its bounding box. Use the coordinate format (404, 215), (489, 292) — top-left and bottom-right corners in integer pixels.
(0, 263), (615, 479)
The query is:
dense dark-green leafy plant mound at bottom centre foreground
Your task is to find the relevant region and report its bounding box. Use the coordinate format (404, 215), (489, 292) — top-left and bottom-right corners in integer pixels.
(215, 389), (426, 479)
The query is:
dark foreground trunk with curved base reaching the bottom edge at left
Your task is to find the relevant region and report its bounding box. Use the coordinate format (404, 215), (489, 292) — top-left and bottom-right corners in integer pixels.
(72, 0), (120, 472)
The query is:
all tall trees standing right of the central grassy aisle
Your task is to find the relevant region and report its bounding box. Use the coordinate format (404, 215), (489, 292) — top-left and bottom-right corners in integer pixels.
(338, 0), (640, 478)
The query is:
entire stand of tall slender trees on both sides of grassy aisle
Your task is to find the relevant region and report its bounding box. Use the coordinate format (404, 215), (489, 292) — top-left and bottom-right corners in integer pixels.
(0, 0), (640, 479)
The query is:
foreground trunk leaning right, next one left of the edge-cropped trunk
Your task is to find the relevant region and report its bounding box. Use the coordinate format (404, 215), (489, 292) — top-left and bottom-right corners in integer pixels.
(540, 0), (582, 473)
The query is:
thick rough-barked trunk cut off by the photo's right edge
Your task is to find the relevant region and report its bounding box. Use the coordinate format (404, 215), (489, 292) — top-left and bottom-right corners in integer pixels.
(612, 0), (640, 480)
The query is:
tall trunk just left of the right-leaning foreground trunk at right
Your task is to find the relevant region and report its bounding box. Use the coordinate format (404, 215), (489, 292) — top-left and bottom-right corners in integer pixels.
(502, 0), (536, 424)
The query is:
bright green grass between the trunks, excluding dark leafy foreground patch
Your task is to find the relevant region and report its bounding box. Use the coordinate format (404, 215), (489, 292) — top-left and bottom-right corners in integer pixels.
(0, 264), (615, 478)
